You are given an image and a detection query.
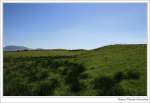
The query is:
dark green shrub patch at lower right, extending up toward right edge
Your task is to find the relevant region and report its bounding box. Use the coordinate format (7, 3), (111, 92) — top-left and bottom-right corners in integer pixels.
(94, 70), (140, 96)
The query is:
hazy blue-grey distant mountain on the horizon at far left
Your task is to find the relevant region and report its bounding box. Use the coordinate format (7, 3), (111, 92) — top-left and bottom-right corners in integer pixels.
(4, 45), (30, 51)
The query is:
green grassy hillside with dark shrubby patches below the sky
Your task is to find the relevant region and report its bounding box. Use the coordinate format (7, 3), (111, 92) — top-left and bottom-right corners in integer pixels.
(4, 44), (147, 96)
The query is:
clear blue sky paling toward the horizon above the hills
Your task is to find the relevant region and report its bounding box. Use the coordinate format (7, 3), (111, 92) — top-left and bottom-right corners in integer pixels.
(3, 3), (147, 49)
